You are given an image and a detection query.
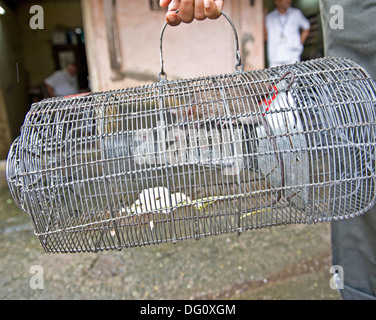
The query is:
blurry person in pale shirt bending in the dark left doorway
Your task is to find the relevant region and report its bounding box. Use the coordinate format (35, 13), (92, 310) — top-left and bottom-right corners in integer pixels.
(44, 64), (80, 97)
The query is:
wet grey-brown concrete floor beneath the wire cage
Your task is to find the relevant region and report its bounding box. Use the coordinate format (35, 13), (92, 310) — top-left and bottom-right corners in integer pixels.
(0, 162), (341, 300)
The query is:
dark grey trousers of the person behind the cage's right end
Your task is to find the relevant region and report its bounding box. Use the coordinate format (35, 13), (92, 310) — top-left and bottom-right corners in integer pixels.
(320, 0), (376, 299)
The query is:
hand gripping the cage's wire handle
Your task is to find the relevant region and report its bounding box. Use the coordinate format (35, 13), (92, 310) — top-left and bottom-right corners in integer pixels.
(159, 0), (224, 26)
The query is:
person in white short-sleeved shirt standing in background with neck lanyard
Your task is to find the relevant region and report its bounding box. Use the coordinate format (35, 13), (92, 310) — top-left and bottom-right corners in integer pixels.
(265, 0), (310, 67)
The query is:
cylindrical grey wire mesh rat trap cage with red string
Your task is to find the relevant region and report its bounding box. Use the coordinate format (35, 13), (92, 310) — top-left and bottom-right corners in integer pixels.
(7, 12), (376, 252)
